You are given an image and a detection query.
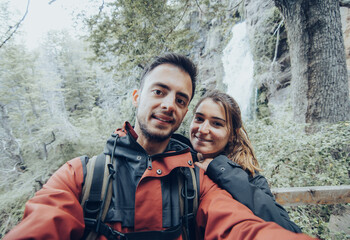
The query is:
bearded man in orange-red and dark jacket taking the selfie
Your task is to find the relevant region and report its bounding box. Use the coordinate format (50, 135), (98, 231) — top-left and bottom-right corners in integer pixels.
(4, 54), (318, 239)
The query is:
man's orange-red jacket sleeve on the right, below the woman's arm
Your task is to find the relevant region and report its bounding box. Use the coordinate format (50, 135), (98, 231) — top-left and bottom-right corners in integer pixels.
(196, 173), (314, 240)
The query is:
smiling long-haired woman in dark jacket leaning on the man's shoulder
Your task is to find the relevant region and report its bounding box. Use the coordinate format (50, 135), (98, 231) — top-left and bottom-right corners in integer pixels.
(190, 91), (301, 232)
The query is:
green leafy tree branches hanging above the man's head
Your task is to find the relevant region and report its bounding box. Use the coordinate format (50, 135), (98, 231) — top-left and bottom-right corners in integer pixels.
(86, 0), (197, 73)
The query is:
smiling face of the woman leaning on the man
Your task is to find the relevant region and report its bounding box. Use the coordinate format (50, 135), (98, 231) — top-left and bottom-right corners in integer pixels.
(190, 98), (230, 157)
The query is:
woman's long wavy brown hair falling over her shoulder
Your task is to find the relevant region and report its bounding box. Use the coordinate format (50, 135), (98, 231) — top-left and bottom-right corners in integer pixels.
(194, 90), (262, 176)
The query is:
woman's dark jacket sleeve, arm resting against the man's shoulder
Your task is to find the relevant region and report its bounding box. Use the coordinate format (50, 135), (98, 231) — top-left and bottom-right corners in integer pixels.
(207, 155), (301, 232)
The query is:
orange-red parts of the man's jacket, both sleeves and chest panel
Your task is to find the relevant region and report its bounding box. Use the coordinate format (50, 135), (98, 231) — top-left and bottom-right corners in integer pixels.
(4, 124), (318, 240)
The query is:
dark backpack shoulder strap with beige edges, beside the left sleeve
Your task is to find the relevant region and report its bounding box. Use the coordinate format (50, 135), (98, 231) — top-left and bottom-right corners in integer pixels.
(81, 153), (112, 239)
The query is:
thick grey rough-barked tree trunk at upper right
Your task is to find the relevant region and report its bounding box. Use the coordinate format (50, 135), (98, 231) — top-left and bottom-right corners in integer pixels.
(275, 0), (350, 124)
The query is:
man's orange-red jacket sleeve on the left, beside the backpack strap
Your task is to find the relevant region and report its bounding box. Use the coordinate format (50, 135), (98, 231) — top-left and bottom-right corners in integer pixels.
(4, 158), (84, 240)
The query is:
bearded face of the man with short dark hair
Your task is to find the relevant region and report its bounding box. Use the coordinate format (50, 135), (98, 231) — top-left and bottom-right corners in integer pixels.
(133, 64), (192, 142)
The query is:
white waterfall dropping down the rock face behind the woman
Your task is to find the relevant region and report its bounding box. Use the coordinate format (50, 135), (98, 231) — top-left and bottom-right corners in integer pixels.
(222, 22), (254, 119)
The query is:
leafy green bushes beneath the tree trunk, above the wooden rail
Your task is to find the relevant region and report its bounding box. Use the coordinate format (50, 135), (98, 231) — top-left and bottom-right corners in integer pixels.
(248, 120), (350, 187)
